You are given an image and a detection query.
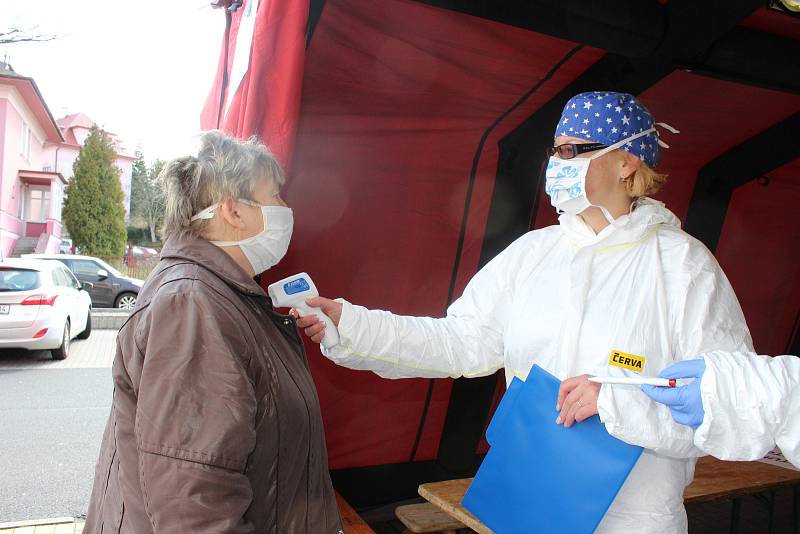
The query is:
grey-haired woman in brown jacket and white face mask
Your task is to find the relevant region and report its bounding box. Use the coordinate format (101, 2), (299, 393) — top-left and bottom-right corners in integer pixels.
(84, 132), (342, 534)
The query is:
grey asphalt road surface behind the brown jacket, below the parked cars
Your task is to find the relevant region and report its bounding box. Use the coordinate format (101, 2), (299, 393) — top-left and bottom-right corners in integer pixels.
(0, 330), (116, 522)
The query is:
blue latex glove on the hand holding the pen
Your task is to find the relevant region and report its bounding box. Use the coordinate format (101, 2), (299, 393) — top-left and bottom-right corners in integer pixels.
(642, 360), (706, 429)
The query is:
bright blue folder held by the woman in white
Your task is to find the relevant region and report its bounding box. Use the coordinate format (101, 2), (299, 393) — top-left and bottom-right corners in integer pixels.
(462, 365), (642, 534)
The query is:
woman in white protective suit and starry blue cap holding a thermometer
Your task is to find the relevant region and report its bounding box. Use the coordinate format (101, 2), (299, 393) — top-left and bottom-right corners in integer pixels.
(298, 92), (751, 534)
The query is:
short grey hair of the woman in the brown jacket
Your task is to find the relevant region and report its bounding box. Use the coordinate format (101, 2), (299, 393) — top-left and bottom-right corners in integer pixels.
(159, 130), (285, 238)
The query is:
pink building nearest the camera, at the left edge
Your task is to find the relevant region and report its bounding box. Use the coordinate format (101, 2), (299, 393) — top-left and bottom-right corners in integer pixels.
(0, 63), (67, 257)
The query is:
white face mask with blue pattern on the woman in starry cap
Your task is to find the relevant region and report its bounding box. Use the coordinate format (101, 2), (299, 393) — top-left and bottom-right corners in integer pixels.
(545, 128), (655, 224)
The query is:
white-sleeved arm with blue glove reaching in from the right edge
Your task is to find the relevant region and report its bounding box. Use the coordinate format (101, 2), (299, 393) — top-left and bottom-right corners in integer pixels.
(642, 351), (800, 467)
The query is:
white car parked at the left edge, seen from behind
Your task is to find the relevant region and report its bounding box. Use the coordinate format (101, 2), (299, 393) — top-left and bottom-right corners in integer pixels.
(0, 258), (92, 360)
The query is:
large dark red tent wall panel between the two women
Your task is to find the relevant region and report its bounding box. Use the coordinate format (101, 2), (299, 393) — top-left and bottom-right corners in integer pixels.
(269, 0), (602, 468)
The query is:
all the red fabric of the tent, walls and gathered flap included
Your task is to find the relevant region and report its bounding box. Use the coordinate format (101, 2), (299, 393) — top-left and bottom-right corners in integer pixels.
(203, 0), (800, 480)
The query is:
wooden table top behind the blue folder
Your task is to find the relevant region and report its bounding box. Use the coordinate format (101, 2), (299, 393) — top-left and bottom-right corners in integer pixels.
(419, 456), (800, 534)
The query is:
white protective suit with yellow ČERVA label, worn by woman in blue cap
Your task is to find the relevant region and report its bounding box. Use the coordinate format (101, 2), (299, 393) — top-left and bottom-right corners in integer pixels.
(323, 199), (752, 534)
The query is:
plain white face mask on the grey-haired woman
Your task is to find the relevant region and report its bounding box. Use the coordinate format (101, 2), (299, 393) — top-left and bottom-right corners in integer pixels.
(192, 199), (294, 274)
